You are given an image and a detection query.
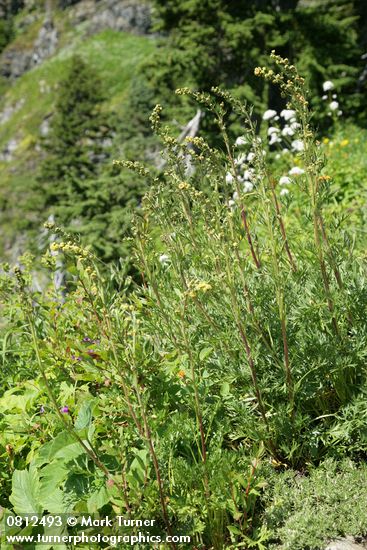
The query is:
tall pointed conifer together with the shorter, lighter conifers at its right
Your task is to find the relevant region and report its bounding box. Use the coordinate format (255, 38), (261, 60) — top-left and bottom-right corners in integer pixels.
(36, 57), (147, 263)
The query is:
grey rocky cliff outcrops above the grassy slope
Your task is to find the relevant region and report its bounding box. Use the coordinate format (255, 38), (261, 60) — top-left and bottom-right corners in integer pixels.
(0, 0), (151, 80)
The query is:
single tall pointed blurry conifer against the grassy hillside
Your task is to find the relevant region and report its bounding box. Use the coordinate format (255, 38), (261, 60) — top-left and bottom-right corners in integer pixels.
(39, 56), (110, 213)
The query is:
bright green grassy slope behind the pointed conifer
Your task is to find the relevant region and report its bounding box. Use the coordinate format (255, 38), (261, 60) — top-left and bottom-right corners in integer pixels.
(0, 3), (155, 257)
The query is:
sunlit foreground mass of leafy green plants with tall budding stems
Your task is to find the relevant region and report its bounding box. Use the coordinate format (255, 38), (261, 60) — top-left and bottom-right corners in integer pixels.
(0, 56), (367, 550)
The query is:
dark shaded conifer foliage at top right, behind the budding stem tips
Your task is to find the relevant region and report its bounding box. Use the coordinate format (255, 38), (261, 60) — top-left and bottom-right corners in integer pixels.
(128, 0), (366, 139)
